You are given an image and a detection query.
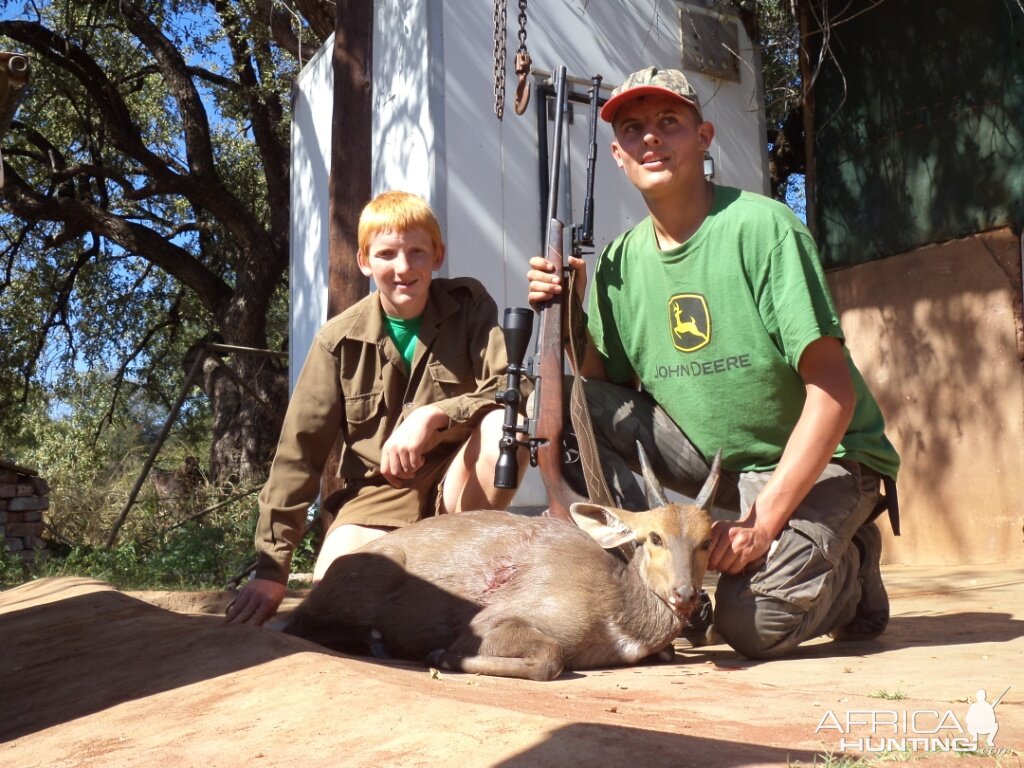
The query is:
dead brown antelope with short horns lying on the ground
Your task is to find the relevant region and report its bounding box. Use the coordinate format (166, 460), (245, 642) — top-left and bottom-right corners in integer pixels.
(285, 448), (720, 680)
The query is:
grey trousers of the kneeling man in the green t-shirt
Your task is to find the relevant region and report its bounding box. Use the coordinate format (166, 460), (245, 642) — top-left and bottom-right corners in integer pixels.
(565, 381), (881, 658)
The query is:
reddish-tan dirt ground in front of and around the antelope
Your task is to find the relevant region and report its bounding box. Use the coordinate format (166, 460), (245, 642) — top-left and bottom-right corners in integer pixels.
(0, 565), (1024, 768)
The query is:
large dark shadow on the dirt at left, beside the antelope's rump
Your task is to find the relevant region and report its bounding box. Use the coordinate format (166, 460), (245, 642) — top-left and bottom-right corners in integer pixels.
(0, 579), (296, 741)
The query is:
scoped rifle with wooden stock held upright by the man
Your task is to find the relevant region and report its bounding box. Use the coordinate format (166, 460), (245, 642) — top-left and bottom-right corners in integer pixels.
(495, 67), (601, 519)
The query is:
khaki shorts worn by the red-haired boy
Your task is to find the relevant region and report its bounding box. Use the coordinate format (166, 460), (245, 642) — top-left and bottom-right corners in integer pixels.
(324, 425), (475, 534)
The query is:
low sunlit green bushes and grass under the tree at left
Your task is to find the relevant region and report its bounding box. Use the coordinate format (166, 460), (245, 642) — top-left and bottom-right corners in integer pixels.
(0, 372), (327, 590)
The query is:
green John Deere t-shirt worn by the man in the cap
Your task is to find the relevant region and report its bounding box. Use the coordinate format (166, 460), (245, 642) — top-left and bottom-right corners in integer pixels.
(590, 186), (899, 478)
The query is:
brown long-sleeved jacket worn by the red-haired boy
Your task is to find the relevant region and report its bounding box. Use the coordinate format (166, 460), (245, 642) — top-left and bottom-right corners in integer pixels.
(256, 278), (508, 583)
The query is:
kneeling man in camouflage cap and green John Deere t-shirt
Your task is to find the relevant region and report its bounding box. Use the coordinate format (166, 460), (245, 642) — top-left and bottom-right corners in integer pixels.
(527, 68), (899, 658)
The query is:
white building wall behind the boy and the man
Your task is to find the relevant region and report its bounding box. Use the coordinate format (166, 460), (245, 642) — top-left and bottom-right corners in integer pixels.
(290, 0), (767, 512)
